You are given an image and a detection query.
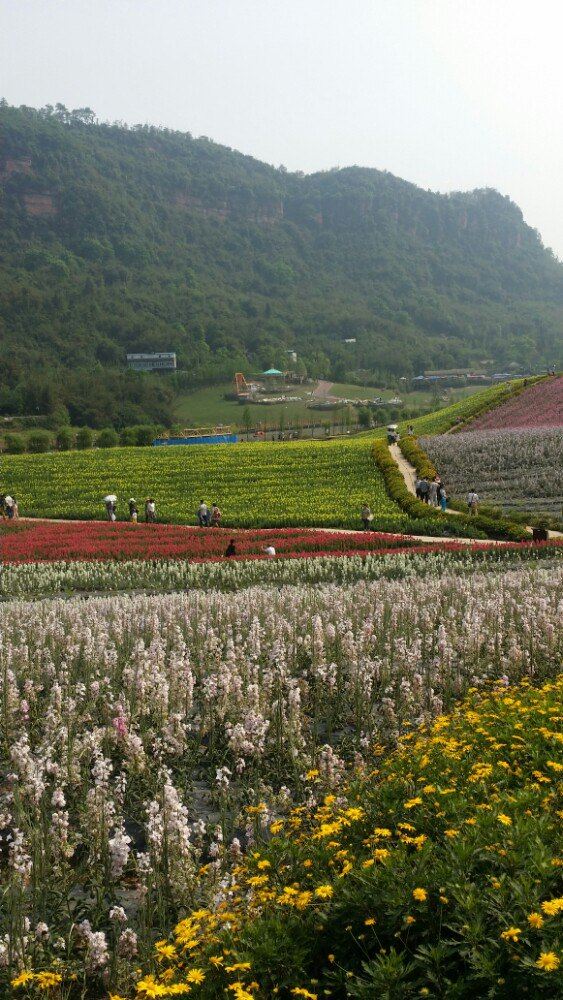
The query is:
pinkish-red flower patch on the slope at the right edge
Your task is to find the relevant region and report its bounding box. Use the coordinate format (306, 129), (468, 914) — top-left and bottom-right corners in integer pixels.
(467, 377), (563, 431)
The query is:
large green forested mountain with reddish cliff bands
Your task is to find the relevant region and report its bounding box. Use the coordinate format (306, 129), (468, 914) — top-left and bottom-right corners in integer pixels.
(0, 102), (563, 424)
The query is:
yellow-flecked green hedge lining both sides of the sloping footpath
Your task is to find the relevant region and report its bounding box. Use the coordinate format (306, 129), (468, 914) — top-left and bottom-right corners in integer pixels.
(372, 438), (530, 542)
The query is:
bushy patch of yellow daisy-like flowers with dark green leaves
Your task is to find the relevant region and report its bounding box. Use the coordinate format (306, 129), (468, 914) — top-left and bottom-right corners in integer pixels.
(141, 676), (563, 1000)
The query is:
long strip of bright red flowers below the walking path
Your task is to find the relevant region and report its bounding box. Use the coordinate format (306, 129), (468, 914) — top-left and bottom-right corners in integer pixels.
(0, 521), (428, 563)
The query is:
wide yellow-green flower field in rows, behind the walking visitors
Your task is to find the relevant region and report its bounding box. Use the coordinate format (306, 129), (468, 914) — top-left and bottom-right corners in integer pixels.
(2, 438), (404, 530)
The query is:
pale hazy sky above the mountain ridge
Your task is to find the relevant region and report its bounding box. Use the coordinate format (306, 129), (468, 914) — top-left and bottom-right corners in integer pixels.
(0, 0), (563, 257)
